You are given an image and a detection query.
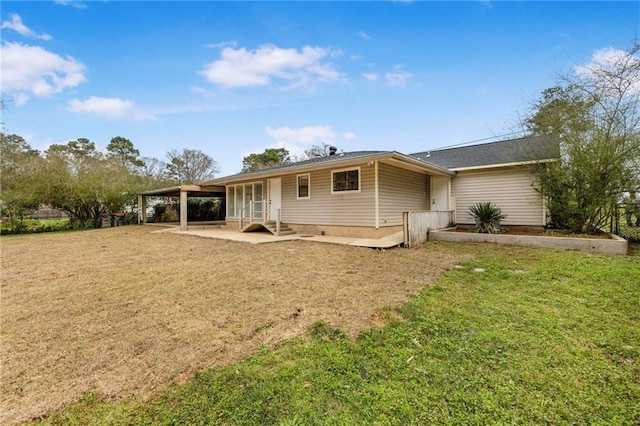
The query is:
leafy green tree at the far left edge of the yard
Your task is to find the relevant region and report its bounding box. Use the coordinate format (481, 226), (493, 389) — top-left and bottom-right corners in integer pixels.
(0, 133), (43, 227)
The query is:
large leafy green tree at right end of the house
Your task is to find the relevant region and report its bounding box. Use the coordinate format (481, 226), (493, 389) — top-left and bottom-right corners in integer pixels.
(525, 45), (640, 233)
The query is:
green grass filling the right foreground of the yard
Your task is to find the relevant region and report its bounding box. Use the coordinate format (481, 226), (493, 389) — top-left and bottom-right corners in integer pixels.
(33, 243), (640, 425)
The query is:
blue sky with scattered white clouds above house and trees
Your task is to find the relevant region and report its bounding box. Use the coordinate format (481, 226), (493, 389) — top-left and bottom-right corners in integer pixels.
(0, 0), (640, 175)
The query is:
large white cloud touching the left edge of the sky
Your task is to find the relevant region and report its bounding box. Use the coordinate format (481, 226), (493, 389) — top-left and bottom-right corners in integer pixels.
(0, 43), (87, 99)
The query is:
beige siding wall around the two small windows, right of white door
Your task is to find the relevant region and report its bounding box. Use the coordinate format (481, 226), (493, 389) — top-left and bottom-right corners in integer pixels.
(282, 163), (375, 226)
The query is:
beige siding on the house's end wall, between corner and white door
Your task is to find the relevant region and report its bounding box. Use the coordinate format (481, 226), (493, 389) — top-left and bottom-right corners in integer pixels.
(378, 163), (430, 226)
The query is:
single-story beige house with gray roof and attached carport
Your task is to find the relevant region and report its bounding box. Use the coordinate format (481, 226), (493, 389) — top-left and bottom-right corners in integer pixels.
(140, 137), (559, 238)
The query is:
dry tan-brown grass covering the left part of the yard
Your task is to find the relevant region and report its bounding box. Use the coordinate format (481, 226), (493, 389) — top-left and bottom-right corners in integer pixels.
(0, 226), (463, 424)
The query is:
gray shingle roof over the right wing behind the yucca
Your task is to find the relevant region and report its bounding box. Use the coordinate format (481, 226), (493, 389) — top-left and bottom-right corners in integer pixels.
(410, 136), (560, 169)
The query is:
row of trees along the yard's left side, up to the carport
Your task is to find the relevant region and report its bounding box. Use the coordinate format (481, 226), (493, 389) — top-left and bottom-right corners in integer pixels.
(0, 133), (219, 228)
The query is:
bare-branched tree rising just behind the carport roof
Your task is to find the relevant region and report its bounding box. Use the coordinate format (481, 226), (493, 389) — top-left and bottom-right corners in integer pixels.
(166, 149), (220, 184)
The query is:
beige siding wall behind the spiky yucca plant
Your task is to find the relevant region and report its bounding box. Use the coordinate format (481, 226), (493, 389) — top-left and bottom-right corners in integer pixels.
(451, 167), (545, 226)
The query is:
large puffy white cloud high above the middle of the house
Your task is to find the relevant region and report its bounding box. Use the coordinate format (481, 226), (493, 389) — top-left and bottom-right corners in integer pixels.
(201, 44), (344, 89)
